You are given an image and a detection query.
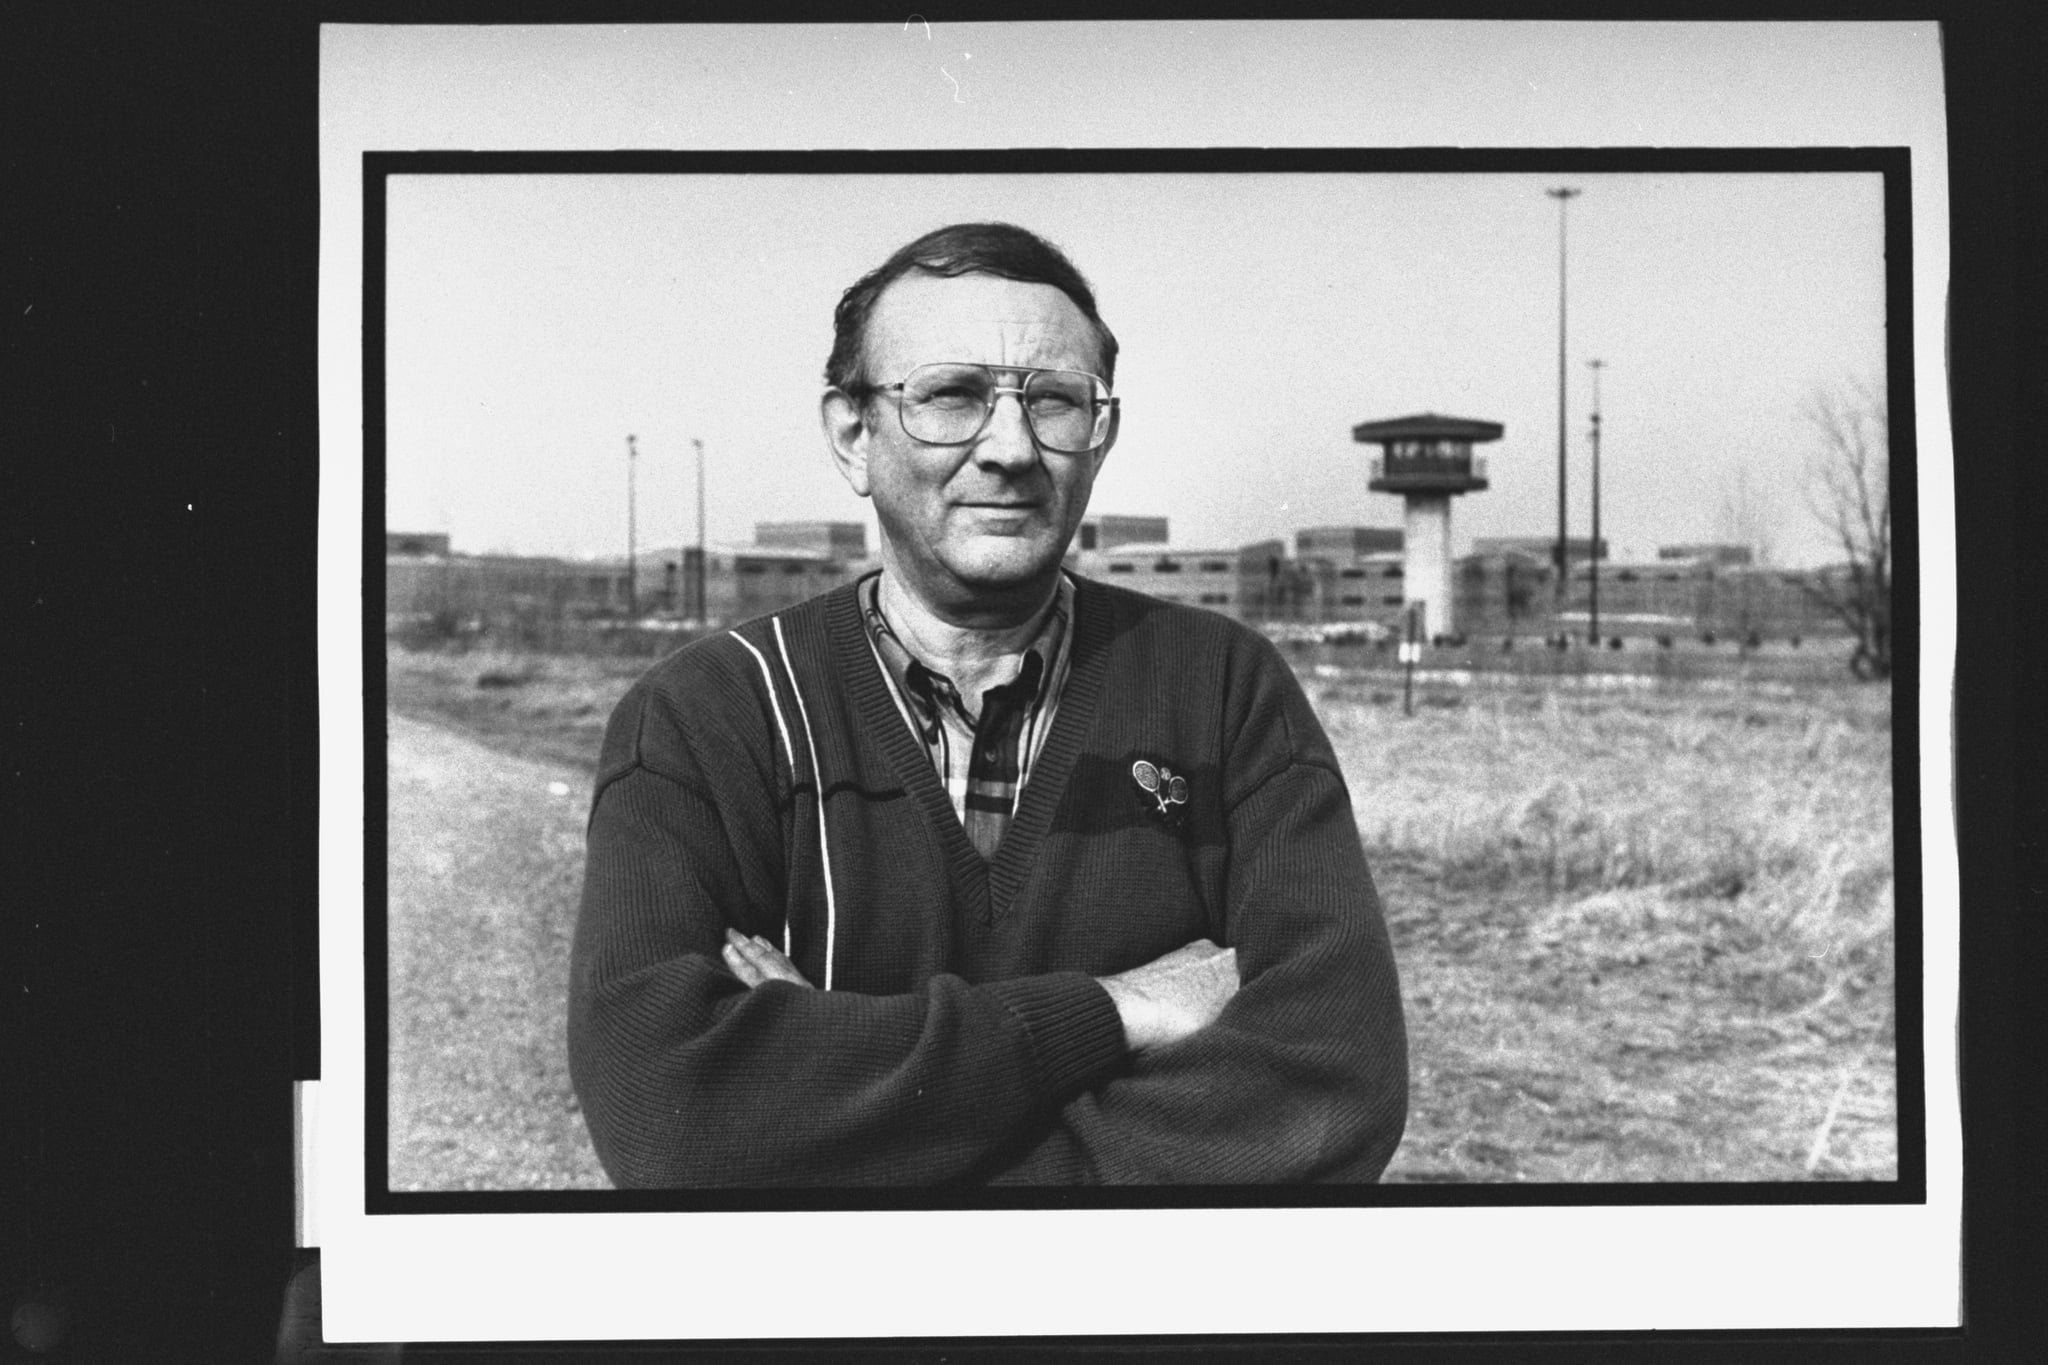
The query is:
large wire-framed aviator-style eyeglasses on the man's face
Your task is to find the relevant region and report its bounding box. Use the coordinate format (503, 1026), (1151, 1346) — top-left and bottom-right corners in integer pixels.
(870, 362), (1116, 454)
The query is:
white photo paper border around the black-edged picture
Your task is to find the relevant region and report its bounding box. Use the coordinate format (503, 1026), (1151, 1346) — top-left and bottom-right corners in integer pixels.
(301, 18), (1962, 1342)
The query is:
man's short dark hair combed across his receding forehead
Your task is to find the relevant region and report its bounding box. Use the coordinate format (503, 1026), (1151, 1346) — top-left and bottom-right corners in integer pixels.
(825, 223), (1116, 397)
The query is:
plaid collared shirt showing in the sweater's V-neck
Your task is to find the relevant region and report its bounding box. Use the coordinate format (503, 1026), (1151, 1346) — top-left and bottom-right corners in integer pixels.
(860, 573), (1073, 860)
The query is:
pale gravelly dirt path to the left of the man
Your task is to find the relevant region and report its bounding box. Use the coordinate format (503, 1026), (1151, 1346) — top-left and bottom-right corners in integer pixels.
(389, 714), (606, 1189)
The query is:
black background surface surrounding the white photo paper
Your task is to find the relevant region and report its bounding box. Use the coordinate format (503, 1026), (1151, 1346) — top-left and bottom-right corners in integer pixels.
(0, 4), (2048, 1363)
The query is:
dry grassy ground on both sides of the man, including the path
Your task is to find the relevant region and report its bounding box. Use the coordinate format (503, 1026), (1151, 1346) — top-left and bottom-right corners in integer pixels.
(389, 649), (1898, 1189)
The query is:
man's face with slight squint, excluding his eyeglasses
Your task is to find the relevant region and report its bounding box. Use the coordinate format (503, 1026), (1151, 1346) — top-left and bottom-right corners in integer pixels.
(825, 272), (1114, 614)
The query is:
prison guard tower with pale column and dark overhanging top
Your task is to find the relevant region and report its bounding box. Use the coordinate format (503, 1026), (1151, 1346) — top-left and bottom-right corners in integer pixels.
(1352, 411), (1505, 636)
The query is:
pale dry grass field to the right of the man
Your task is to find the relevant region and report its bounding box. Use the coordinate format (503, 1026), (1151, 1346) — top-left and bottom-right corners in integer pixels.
(1311, 667), (1898, 1181)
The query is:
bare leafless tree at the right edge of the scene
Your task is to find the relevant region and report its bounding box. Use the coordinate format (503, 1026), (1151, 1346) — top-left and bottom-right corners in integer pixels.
(1802, 379), (1892, 679)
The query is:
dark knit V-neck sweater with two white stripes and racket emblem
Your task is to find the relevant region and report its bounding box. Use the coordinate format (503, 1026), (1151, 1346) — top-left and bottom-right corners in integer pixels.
(569, 579), (1407, 1187)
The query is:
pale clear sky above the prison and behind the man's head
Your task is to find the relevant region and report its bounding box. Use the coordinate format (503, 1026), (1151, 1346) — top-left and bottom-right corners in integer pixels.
(387, 174), (1884, 563)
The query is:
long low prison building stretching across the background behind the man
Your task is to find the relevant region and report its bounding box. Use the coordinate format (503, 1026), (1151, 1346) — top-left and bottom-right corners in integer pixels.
(385, 518), (1849, 641)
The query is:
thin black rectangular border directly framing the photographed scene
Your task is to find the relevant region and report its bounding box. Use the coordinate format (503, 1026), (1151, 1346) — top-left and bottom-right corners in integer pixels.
(364, 147), (1927, 1216)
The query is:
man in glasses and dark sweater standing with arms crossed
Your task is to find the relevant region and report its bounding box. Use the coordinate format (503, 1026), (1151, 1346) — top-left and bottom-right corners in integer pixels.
(569, 223), (1407, 1187)
